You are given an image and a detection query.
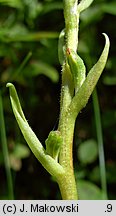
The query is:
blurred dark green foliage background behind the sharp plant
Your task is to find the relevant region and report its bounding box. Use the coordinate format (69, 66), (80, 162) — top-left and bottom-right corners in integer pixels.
(0, 0), (116, 200)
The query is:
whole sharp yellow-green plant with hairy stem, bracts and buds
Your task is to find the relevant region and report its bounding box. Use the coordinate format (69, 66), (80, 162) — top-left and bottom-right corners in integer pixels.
(7, 0), (109, 199)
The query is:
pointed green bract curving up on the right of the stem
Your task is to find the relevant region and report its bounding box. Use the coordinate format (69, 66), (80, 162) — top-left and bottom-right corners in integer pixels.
(69, 33), (110, 117)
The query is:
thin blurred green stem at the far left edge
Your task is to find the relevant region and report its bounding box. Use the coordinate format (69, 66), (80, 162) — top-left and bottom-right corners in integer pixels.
(0, 91), (14, 200)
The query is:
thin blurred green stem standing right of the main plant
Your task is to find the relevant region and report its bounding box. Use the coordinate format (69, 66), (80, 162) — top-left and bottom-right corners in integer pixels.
(92, 89), (108, 199)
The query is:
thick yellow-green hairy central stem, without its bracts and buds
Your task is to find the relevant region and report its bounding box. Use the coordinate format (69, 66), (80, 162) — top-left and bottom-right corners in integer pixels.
(55, 0), (79, 200)
